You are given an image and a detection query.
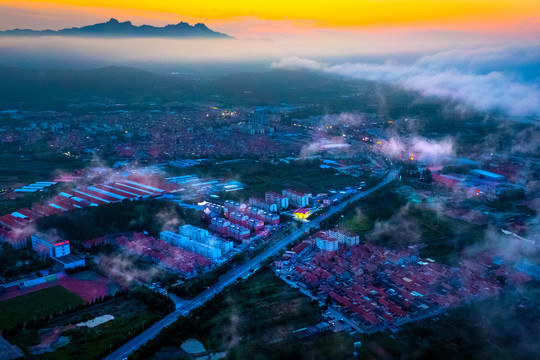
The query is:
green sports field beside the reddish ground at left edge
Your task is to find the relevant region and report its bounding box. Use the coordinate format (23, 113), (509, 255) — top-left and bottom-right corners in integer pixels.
(0, 286), (84, 329)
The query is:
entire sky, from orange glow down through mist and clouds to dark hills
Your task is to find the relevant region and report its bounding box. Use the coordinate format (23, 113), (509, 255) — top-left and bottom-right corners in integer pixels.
(0, 0), (540, 117)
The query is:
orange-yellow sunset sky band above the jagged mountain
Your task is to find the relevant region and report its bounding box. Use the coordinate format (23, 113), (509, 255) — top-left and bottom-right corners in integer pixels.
(0, 0), (540, 33)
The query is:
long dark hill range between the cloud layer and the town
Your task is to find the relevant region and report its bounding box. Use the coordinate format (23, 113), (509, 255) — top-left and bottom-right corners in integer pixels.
(0, 66), (448, 118)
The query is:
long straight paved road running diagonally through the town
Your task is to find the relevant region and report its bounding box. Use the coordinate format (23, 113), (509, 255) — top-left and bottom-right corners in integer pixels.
(104, 169), (399, 360)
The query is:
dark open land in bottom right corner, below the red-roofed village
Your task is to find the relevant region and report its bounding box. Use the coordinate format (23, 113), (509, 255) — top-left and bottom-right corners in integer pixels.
(359, 282), (540, 360)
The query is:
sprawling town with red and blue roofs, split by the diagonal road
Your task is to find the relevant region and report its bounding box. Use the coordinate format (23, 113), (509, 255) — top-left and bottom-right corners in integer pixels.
(0, 96), (540, 359)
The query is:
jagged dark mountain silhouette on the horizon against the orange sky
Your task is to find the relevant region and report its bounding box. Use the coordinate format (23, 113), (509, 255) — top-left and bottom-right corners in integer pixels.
(0, 19), (232, 39)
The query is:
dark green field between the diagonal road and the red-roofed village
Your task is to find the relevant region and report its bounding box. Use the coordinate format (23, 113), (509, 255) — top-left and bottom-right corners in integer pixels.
(134, 268), (327, 359)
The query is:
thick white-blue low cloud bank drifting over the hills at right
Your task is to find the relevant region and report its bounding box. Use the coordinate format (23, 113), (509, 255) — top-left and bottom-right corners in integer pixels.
(272, 52), (540, 116)
